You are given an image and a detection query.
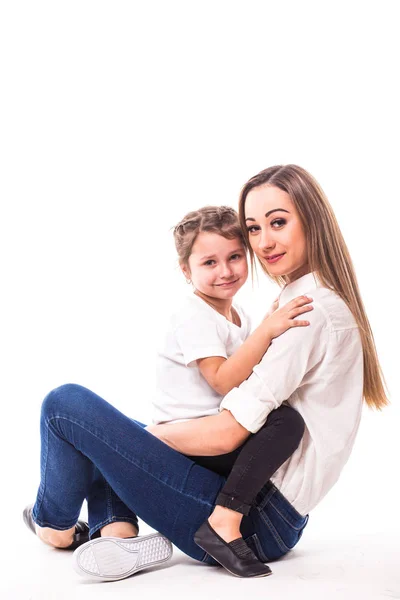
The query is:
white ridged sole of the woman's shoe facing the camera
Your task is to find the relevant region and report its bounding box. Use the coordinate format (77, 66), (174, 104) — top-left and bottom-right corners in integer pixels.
(73, 533), (172, 581)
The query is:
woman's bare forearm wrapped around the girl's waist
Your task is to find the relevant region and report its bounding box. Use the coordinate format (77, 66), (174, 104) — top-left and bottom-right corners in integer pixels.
(146, 410), (250, 456)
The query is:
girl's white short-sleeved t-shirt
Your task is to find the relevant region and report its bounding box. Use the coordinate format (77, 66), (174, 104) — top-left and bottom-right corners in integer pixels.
(153, 294), (250, 424)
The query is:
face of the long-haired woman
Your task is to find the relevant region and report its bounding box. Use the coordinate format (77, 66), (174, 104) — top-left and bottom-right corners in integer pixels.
(245, 185), (309, 281)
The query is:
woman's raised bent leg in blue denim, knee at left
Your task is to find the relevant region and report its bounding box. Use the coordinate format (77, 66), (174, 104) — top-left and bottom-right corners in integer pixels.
(33, 385), (224, 564)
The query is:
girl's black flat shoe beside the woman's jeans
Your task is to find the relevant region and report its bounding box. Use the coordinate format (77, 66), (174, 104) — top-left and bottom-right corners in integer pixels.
(194, 521), (272, 577)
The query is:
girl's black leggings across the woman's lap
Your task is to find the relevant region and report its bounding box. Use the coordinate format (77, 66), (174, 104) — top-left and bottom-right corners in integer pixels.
(190, 405), (304, 515)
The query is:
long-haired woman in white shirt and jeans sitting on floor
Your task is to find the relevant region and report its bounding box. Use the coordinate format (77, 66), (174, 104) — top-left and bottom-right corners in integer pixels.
(22, 165), (387, 579)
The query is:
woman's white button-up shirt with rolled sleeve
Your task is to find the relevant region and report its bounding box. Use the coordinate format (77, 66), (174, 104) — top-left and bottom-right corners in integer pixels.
(220, 273), (363, 515)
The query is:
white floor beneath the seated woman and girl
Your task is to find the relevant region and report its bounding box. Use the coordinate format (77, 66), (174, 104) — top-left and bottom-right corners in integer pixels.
(4, 522), (400, 600)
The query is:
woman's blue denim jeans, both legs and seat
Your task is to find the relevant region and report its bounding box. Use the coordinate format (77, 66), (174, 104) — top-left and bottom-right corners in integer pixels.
(33, 384), (308, 564)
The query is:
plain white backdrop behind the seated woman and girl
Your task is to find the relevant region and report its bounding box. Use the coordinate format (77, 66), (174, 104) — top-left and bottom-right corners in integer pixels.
(0, 0), (400, 538)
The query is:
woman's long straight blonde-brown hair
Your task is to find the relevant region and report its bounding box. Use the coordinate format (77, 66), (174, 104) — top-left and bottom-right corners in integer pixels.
(239, 165), (389, 410)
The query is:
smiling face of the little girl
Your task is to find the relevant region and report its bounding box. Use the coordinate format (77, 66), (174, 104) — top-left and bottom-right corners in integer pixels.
(182, 231), (248, 300)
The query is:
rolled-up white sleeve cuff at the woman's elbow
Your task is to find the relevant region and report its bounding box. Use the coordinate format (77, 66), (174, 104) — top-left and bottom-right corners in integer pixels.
(219, 373), (280, 433)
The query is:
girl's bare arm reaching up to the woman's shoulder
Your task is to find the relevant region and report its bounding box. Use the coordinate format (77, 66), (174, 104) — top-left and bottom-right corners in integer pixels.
(197, 296), (313, 396)
